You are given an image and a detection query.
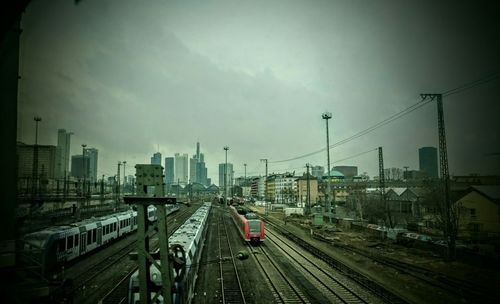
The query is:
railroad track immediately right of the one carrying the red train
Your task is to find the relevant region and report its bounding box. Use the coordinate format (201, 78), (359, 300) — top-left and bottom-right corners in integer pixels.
(266, 229), (376, 303)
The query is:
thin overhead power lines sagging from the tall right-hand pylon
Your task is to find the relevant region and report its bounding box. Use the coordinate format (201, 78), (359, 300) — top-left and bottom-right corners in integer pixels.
(269, 72), (500, 163)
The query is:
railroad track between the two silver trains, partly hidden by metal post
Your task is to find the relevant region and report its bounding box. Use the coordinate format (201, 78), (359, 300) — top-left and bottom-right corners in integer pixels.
(98, 208), (199, 304)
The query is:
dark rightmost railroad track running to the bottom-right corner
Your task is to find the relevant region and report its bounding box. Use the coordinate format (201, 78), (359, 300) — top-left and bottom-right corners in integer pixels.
(315, 236), (495, 303)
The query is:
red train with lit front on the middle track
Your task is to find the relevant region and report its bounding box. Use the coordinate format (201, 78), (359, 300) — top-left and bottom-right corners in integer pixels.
(229, 206), (266, 245)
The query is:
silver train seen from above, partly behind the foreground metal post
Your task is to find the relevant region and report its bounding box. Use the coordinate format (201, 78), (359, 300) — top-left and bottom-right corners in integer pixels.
(128, 202), (212, 304)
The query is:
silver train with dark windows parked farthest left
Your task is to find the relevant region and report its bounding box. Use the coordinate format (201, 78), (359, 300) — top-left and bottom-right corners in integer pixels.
(23, 205), (179, 274)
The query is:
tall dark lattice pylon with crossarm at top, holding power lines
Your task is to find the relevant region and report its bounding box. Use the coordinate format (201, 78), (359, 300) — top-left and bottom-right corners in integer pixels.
(420, 94), (456, 258)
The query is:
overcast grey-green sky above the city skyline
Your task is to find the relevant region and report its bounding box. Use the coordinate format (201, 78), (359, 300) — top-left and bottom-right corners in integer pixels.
(17, 0), (500, 184)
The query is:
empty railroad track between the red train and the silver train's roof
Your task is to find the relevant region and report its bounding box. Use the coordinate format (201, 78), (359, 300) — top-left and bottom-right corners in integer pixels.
(217, 215), (246, 303)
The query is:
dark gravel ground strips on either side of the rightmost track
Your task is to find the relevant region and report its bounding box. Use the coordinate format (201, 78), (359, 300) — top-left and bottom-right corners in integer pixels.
(257, 209), (500, 303)
